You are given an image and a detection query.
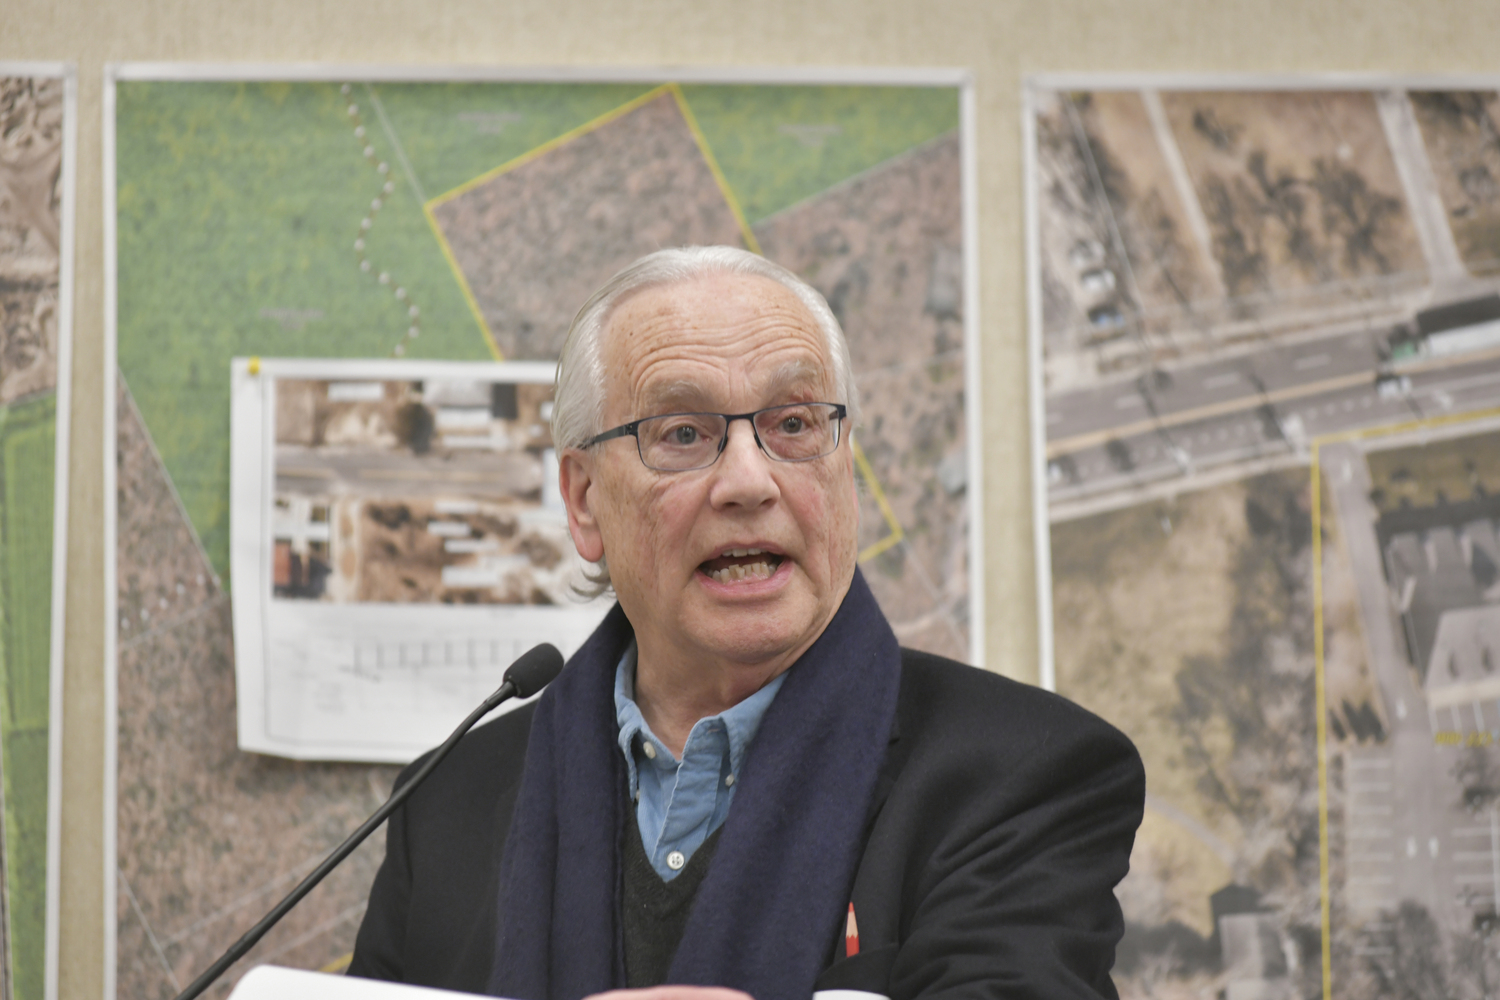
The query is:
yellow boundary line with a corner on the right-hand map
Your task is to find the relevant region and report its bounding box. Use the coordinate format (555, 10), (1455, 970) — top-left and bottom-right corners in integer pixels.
(1310, 409), (1500, 1000)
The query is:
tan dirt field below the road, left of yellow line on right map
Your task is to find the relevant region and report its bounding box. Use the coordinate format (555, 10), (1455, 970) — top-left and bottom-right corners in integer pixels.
(1052, 471), (1319, 997)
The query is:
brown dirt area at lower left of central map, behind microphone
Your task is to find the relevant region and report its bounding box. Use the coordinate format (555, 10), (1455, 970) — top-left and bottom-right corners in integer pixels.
(117, 391), (396, 1000)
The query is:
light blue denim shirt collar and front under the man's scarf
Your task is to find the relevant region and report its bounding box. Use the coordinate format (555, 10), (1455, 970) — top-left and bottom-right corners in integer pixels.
(615, 643), (786, 882)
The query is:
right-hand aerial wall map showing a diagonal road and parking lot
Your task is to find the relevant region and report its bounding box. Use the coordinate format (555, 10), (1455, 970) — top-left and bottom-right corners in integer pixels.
(1028, 78), (1500, 1000)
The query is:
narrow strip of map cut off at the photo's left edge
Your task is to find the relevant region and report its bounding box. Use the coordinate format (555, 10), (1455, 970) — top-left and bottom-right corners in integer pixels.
(0, 61), (75, 1000)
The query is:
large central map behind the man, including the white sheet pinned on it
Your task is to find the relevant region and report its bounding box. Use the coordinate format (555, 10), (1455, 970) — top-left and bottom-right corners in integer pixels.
(105, 64), (983, 997)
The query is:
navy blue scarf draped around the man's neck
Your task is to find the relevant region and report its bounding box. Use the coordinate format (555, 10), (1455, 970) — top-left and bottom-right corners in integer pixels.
(491, 571), (902, 1000)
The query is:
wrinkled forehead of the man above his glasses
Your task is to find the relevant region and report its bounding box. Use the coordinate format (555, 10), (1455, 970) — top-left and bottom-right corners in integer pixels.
(600, 274), (834, 418)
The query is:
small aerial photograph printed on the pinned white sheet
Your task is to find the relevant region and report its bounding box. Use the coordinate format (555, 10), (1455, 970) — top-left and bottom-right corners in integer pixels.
(272, 379), (584, 604)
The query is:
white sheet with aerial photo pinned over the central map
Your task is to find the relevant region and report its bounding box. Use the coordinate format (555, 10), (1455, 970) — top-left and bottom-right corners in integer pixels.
(230, 358), (609, 763)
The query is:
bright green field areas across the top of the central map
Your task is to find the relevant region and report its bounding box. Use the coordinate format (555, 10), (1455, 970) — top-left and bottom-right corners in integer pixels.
(117, 81), (959, 579)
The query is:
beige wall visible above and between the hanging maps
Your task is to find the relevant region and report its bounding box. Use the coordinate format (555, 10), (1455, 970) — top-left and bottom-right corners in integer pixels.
(0, 0), (1500, 997)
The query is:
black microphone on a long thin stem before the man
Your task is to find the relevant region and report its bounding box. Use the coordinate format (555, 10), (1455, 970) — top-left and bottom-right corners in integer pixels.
(177, 642), (563, 1000)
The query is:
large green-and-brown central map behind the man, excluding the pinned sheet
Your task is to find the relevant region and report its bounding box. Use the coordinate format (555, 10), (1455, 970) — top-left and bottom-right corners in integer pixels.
(113, 67), (975, 997)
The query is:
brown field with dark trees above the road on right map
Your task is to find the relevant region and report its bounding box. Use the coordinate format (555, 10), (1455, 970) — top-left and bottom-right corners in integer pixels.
(1037, 91), (1427, 388)
